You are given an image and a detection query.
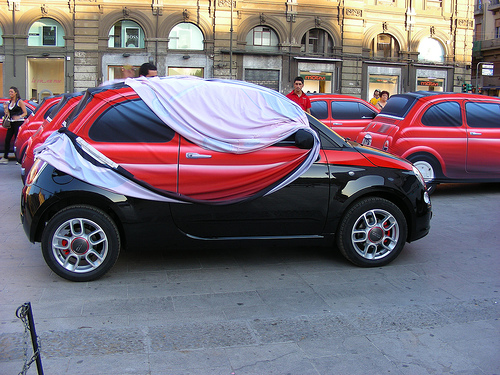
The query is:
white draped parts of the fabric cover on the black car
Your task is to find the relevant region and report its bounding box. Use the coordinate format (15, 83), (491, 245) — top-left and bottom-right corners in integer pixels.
(35, 77), (320, 203)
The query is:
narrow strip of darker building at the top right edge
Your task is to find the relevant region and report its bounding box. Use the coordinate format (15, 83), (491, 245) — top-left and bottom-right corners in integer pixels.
(472, 0), (500, 96)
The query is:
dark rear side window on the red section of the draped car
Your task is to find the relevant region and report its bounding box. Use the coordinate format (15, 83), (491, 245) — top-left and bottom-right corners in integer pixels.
(89, 99), (175, 143)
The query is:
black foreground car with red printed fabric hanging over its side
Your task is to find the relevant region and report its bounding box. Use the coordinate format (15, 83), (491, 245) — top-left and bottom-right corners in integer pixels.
(21, 79), (431, 281)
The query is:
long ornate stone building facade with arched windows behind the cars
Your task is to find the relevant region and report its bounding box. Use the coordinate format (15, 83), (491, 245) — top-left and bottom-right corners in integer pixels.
(0, 0), (474, 100)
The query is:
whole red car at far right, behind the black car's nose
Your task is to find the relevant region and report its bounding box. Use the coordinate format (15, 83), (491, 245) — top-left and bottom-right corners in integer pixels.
(357, 91), (500, 189)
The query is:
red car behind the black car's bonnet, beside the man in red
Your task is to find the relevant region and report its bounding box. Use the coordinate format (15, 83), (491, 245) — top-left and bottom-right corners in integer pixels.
(308, 94), (379, 140)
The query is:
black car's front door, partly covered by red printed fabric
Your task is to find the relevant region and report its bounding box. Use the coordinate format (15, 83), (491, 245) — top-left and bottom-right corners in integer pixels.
(171, 132), (329, 238)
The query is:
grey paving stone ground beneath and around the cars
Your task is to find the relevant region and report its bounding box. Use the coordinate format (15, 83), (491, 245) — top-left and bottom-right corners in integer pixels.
(0, 161), (500, 375)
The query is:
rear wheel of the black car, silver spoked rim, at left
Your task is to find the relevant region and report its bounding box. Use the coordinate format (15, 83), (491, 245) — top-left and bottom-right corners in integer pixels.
(41, 206), (120, 281)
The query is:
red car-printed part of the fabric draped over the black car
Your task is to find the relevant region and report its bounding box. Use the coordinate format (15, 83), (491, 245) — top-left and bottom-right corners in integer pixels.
(68, 87), (308, 201)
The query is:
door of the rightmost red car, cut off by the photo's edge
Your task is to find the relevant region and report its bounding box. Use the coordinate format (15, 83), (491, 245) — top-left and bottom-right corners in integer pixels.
(465, 101), (500, 178)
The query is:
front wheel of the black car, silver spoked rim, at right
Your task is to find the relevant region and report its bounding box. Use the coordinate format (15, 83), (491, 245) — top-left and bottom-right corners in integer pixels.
(337, 197), (408, 267)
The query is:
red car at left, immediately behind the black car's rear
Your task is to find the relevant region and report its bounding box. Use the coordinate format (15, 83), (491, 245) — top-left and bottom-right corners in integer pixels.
(21, 92), (83, 180)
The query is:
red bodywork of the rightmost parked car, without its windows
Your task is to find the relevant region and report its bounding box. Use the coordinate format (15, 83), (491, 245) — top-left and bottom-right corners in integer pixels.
(357, 93), (500, 182)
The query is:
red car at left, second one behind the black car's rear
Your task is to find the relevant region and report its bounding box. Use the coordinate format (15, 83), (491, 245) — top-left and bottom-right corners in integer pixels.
(14, 95), (62, 162)
